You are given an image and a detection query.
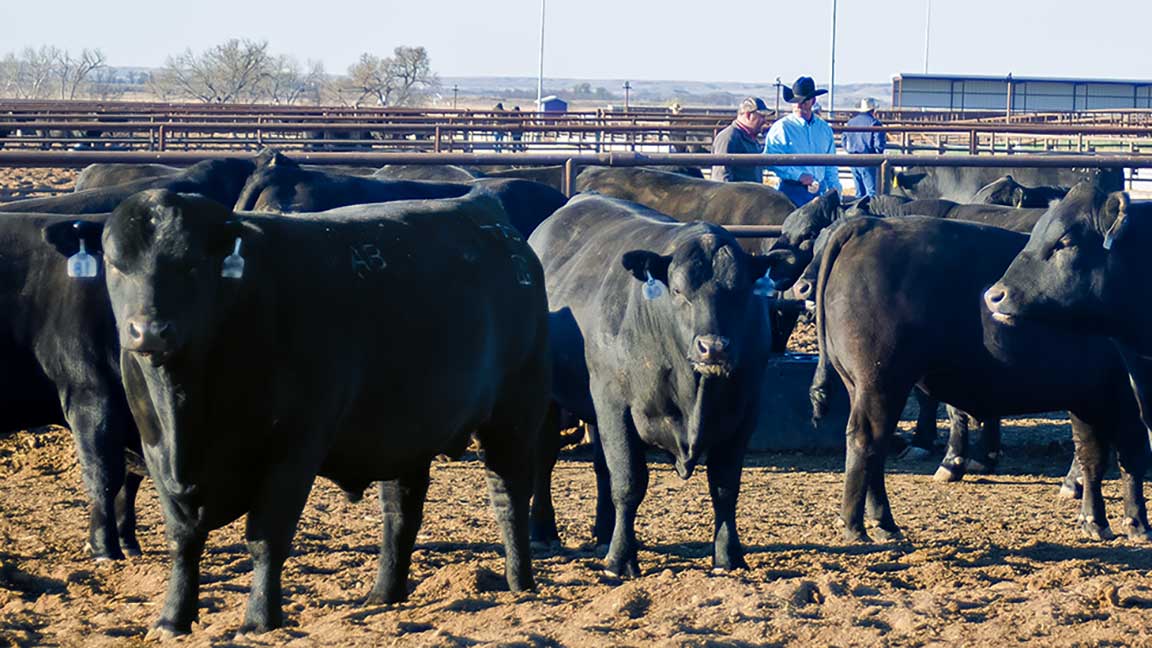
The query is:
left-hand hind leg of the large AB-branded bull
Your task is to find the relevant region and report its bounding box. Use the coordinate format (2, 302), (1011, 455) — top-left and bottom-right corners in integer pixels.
(367, 464), (429, 604)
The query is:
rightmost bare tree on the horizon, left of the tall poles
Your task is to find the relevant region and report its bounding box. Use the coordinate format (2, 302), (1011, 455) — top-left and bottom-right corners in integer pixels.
(348, 45), (439, 106)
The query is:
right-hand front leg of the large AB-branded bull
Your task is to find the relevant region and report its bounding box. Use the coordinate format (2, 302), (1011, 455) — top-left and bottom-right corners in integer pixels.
(240, 458), (320, 633)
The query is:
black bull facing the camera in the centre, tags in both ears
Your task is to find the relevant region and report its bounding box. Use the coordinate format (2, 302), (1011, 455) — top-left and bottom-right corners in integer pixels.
(530, 195), (790, 575)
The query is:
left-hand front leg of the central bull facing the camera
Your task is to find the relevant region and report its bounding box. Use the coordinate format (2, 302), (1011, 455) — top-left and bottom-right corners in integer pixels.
(596, 404), (649, 578)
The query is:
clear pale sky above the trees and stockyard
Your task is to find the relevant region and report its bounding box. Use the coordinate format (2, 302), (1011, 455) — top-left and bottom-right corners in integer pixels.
(0, 0), (1152, 85)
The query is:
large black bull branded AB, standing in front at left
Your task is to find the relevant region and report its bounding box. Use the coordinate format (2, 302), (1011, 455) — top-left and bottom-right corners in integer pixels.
(61, 191), (550, 633)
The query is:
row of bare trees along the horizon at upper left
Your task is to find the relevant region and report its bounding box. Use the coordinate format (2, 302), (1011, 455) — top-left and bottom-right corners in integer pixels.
(0, 38), (439, 107)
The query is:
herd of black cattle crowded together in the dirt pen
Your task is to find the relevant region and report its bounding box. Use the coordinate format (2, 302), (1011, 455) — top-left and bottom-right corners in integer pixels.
(0, 151), (1152, 634)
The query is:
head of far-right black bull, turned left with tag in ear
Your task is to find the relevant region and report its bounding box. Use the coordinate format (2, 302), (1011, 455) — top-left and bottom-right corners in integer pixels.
(984, 182), (1133, 336)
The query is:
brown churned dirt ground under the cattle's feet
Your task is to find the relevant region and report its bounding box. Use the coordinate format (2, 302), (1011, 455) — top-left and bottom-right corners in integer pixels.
(0, 167), (1152, 647)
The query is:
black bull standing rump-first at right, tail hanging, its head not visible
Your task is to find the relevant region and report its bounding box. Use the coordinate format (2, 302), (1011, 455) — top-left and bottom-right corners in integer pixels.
(812, 217), (1149, 540)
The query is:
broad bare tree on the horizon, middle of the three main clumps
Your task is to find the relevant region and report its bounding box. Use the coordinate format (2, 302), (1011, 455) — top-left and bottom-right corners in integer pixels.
(160, 38), (273, 104)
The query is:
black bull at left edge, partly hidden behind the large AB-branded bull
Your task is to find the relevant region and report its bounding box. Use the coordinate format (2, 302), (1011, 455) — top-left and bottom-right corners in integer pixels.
(0, 213), (141, 559)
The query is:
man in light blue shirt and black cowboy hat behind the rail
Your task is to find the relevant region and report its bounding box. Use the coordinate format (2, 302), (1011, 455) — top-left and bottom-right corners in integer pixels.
(764, 76), (840, 206)
